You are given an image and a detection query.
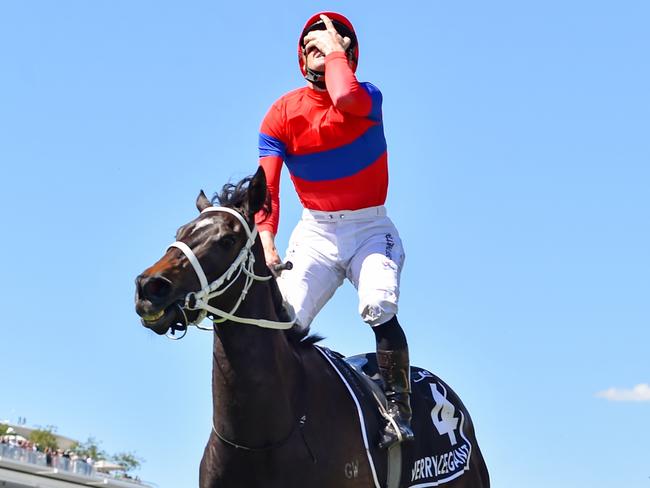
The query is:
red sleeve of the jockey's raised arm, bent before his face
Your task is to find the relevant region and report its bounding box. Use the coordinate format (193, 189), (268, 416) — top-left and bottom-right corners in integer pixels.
(325, 52), (372, 116)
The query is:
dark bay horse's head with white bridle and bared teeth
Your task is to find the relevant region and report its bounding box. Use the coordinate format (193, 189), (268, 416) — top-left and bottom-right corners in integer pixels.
(135, 168), (266, 334)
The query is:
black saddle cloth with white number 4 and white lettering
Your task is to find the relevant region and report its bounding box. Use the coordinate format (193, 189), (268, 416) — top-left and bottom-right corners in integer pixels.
(317, 346), (483, 488)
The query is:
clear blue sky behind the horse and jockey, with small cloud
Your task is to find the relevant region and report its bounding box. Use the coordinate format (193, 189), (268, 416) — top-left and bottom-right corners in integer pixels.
(0, 0), (650, 488)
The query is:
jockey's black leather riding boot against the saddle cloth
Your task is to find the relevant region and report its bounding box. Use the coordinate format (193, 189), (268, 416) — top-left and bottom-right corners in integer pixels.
(377, 347), (414, 448)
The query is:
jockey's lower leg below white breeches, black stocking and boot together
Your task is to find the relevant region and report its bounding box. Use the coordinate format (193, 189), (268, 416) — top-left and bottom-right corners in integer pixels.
(372, 316), (414, 447)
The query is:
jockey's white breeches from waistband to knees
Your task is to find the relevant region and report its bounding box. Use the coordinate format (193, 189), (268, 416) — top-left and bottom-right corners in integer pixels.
(278, 206), (405, 328)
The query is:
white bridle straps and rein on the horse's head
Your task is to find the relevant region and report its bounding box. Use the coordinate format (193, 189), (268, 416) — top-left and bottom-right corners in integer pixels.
(168, 207), (295, 337)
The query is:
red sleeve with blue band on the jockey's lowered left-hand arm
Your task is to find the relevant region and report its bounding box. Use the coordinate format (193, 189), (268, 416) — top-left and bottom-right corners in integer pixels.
(255, 102), (286, 235)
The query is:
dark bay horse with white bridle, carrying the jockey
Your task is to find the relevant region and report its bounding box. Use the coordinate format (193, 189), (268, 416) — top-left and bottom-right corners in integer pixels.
(136, 166), (489, 488)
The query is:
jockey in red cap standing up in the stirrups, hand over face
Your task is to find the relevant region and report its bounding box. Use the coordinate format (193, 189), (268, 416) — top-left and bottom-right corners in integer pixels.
(256, 12), (413, 447)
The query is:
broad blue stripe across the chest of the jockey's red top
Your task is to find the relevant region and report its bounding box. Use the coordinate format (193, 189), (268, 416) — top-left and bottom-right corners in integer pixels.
(286, 124), (386, 181)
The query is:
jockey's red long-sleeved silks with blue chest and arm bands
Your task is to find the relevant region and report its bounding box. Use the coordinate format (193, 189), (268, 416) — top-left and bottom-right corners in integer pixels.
(256, 52), (388, 234)
